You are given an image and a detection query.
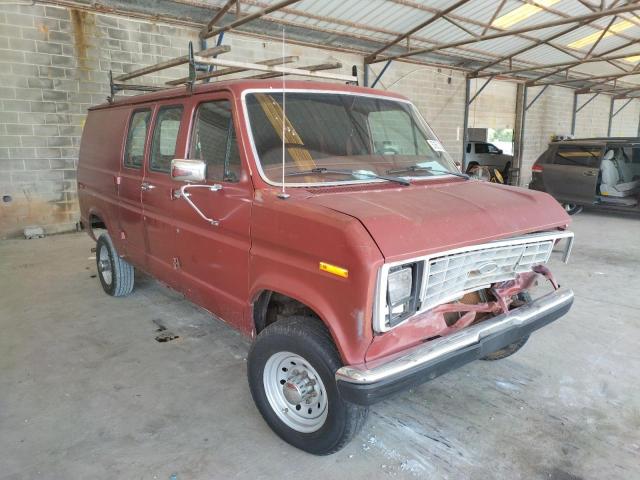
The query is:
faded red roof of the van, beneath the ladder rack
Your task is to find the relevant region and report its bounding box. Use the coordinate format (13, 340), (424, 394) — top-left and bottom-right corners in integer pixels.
(89, 78), (407, 110)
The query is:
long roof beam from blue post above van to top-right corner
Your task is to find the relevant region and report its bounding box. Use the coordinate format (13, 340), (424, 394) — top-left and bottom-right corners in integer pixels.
(367, 4), (640, 63)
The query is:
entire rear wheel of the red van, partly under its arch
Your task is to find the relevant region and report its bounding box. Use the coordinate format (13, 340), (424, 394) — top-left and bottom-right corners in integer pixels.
(96, 233), (134, 297)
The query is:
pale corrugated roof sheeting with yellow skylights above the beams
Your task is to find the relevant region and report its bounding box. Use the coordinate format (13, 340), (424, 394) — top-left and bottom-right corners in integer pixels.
(126, 0), (640, 92)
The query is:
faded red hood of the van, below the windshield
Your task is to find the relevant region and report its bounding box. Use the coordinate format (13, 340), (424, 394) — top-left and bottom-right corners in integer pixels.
(307, 179), (570, 260)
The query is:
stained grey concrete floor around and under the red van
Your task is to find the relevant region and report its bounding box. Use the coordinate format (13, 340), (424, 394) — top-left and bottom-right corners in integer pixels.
(0, 212), (640, 480)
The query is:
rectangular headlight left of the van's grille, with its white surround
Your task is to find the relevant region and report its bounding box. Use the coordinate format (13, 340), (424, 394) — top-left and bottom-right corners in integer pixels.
(374, 262), (424, 332)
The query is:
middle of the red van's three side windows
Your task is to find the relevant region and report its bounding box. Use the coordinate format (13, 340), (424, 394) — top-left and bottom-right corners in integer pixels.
(151, 106), (182, 173)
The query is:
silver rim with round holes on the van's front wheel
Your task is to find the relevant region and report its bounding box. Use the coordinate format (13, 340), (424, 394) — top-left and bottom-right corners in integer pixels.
(262, 352), (329, 433)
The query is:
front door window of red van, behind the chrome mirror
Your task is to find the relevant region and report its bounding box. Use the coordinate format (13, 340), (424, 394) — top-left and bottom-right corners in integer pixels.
(189, 100), (241, 182)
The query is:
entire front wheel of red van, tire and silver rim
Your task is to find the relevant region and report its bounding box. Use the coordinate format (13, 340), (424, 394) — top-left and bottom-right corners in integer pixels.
(247, 317), (368, 455)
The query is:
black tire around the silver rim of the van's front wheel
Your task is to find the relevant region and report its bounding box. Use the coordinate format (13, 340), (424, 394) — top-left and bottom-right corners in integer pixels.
(247, 317), (368, 455)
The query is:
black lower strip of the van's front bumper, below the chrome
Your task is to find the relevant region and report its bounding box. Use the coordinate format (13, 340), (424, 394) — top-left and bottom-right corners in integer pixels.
(337, 299), (573, 405)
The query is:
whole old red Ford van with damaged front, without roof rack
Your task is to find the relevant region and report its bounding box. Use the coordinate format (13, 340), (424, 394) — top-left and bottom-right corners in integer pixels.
(78, 80), (573, 454)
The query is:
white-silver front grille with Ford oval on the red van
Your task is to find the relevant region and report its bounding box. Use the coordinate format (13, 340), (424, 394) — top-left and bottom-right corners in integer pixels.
(420, 240), (553, 310)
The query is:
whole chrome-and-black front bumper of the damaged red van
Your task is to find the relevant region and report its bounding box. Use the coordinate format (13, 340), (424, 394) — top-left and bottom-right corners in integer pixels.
(336, 288), (573, 405)
